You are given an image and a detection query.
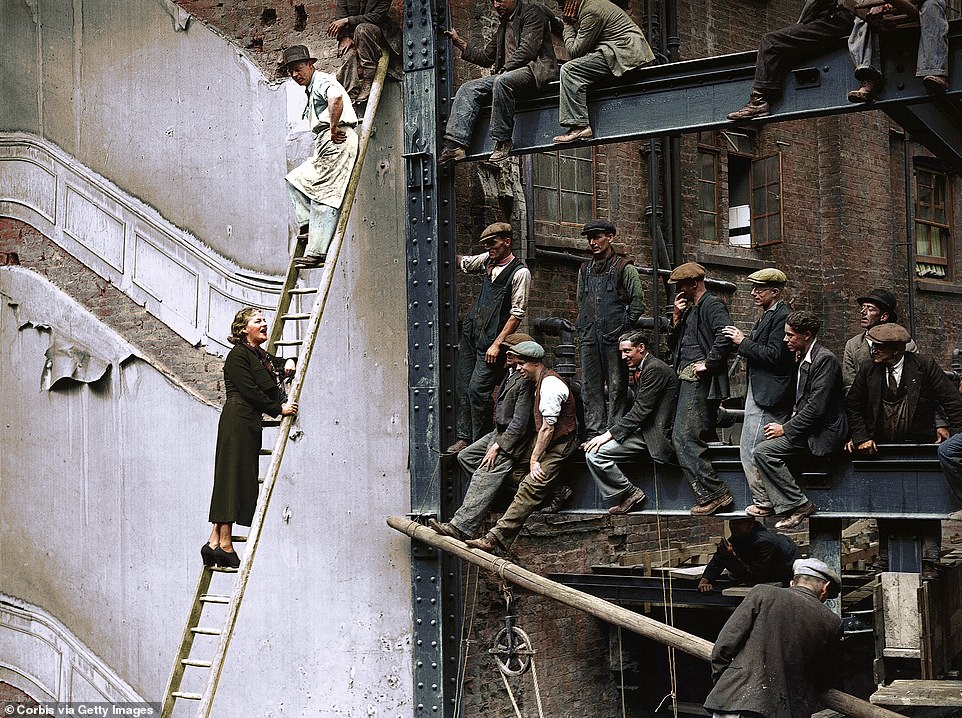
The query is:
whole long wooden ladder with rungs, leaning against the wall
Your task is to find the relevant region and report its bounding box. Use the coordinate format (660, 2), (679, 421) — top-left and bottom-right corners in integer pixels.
(161, 52), (388, 718)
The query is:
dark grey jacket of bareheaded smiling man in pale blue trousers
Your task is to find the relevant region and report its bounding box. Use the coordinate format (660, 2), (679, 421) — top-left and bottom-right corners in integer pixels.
(609, 354), (678, 464)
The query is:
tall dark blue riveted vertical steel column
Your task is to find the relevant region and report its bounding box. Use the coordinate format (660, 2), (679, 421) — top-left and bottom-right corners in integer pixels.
(398, 0), (459, 717)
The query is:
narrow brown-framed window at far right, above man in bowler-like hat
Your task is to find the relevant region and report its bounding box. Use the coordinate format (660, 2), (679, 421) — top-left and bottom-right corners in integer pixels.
(915, 166), (952, 279)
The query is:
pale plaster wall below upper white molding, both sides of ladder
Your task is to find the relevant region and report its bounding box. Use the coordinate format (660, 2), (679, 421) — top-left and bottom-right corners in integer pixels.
(0, 101), (412, 716)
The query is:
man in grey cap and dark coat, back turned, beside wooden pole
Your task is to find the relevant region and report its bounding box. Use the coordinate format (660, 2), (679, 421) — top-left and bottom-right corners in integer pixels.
(705, 558), (842, 718)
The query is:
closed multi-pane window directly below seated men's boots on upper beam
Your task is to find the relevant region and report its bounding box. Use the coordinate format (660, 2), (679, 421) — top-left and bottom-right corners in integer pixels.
(531, 147), (595, 245)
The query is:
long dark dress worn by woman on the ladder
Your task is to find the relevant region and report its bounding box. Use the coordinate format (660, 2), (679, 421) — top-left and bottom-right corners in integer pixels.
(210, 344), (281, 526)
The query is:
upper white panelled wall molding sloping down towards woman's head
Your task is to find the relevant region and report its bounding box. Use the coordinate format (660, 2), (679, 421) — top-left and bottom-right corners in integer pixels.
(0, 132), (292, 355)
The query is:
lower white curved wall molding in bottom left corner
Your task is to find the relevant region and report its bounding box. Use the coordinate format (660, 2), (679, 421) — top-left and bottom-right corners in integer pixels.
(0, 593), (144, 703)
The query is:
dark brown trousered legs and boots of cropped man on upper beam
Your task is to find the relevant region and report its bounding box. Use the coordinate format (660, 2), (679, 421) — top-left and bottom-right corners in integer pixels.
(728, 0), (855, 121)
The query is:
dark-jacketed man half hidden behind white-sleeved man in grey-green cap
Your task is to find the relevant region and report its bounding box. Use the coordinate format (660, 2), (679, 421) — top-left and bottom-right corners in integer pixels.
(428, 333), (534, 541)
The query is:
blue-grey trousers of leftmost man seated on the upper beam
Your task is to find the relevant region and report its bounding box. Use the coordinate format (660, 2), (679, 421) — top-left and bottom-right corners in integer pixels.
(444, 66), (538, 147)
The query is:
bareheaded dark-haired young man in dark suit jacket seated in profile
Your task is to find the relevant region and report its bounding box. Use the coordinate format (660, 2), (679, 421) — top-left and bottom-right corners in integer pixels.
(755, 311), (848, 530)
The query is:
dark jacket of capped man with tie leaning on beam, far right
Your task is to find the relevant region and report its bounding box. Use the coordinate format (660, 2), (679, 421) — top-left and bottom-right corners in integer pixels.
(846, 352), (962, 445)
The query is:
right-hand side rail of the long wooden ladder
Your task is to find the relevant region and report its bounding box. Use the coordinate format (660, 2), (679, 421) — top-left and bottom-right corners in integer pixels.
(191, 51), (388, 718)
